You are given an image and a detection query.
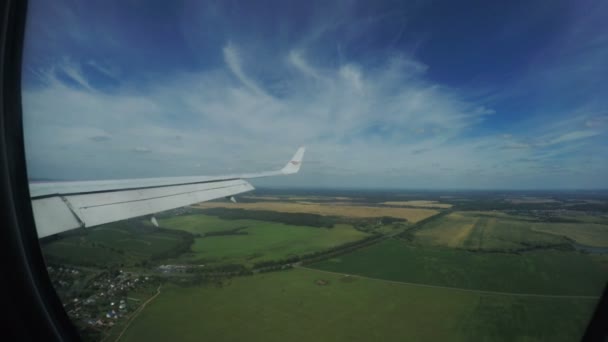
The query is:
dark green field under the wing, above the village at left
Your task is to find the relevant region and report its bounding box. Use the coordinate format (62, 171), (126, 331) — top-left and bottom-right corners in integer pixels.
(42, 221), (185, 266)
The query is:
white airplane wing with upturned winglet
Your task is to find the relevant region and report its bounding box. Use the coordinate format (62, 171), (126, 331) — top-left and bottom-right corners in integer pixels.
(30, 147), (305, 238)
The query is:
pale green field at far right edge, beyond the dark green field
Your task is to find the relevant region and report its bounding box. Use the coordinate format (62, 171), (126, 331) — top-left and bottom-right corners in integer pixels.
(532, 223), (608, 247)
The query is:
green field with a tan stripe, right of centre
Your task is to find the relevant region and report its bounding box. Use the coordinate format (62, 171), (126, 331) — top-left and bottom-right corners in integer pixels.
(414, 212), (569, 251)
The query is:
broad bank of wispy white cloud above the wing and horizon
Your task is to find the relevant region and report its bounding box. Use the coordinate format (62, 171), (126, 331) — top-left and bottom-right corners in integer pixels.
(24, 44), (597, 187)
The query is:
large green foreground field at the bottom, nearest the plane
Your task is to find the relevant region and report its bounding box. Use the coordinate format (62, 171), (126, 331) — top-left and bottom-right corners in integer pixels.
(120, 269), (595, 341)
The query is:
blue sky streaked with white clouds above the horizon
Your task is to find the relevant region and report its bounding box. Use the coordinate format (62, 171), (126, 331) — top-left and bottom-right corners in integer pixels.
(22, 0), (608, 189)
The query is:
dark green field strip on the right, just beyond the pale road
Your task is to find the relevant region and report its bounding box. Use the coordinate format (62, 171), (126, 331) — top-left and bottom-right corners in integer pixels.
(311, 239), (608, 296)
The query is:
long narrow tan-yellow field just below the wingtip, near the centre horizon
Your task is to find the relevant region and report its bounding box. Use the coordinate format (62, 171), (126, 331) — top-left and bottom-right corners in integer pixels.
(196, 202), (438, 223)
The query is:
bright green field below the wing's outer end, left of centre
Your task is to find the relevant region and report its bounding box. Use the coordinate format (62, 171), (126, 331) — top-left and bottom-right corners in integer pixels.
(159, 214), (368, 264)
